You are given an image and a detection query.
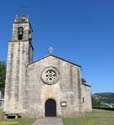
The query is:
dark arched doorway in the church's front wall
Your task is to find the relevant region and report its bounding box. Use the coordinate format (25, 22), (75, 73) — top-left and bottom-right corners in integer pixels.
(45, 99), (56, 117)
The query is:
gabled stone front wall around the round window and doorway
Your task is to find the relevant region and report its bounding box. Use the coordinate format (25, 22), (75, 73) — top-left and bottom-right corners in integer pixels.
(21, 56), (81, 117)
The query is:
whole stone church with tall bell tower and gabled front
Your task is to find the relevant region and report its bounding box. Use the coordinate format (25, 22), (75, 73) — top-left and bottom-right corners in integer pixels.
(4, 16), (92, 118)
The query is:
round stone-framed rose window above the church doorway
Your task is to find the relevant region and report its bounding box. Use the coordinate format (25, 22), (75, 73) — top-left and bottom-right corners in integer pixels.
(41, 67), (59, 85)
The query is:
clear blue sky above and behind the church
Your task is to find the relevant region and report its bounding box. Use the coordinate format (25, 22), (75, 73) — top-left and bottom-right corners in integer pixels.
(0, 0), (114, 93)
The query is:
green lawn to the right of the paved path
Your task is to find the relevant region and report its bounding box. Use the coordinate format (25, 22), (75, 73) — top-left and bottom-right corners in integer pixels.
(64, 110), (114, 125)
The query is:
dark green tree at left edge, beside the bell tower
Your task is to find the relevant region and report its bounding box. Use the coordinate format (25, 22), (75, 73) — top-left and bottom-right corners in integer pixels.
(0, 61), (6, 94)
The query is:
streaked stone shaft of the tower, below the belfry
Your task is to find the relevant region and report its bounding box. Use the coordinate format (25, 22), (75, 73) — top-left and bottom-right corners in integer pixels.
(4, 41), (30, 113)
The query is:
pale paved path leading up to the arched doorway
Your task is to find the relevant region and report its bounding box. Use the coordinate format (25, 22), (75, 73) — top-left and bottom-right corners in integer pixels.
(32, 117), (64, 125)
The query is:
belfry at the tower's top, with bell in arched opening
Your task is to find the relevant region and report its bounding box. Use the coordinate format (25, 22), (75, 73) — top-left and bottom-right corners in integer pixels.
(12, 15), (32, 42)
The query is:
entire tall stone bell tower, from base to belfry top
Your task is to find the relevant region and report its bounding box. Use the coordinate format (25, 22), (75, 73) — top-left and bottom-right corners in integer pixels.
(4, 15), (33, 115)
